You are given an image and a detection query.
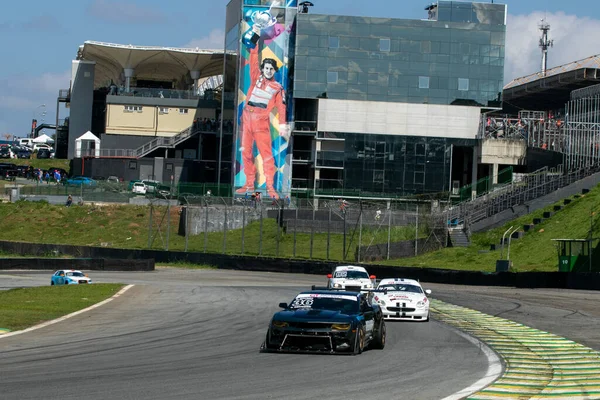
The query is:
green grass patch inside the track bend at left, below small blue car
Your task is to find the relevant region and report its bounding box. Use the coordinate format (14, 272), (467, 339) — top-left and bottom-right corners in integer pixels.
(0, 284), (123, 331)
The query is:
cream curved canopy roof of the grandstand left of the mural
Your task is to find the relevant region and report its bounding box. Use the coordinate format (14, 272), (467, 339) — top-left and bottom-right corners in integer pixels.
(77, 41), (223, 87)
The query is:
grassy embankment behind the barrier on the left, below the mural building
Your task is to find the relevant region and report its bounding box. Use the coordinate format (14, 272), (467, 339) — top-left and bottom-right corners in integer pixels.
(0, 201), (424, 260)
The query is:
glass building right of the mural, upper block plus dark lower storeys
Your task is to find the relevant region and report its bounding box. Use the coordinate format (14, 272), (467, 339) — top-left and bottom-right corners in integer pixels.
(286, 1), (506, 197)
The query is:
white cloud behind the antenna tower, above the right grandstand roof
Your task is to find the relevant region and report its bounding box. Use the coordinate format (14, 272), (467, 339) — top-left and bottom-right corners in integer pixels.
(504, 11), (600, 82)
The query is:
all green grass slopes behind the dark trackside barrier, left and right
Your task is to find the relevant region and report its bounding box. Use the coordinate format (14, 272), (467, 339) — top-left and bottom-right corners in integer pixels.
(0, 187), (600, 272)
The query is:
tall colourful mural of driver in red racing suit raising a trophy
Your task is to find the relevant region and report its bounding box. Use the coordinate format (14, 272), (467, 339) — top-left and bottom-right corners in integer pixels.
(234, 0), (297, 199)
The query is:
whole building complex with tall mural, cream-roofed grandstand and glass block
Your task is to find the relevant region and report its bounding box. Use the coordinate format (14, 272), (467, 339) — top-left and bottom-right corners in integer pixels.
(57, 0), (506, 198)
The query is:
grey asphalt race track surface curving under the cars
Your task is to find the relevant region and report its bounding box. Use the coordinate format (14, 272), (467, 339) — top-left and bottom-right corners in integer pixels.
(0, 268), (600, 399)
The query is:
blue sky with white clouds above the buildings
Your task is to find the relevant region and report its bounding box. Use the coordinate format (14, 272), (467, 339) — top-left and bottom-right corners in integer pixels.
(0, 0), (600, 139)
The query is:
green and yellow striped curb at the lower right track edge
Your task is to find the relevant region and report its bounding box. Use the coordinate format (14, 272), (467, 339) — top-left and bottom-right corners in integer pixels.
(431, 299), (600, 400)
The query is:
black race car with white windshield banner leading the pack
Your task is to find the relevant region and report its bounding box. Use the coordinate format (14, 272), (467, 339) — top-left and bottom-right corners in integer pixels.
(261, 290), (386, 354)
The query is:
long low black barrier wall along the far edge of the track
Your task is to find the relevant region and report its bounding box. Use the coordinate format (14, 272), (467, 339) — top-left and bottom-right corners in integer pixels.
(0, 241), (600, 290)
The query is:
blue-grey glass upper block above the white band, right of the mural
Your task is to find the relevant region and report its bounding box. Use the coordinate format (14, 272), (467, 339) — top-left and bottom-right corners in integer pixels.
(294, 1), (506, 108)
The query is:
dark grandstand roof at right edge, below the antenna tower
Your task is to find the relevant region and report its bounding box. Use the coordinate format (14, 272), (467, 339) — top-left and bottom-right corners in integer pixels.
(502, 55), (600, 111)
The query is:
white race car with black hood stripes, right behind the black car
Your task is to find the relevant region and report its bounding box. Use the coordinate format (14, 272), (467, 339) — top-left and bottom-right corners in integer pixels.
(373, 278), (431, 322)
